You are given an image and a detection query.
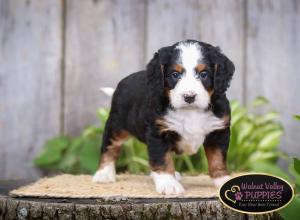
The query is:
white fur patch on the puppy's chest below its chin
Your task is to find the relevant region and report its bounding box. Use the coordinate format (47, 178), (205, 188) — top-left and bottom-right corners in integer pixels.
(164, 110), (225, 154)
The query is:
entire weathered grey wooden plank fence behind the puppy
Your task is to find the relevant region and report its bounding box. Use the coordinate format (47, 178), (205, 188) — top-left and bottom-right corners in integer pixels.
(0, 0), (300, 178)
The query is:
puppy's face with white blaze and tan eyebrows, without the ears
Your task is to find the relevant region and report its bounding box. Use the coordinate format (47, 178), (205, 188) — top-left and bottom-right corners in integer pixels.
(163, 41), (214, 109)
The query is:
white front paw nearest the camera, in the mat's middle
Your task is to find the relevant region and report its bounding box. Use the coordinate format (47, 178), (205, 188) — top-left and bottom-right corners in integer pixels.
(151, 172), (184, 195)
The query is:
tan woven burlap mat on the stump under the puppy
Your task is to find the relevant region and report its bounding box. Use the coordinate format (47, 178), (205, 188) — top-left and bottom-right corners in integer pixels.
(10, 174), (223, 198)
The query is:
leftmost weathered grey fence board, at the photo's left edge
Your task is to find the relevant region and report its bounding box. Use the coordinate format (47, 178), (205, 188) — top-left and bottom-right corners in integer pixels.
(0, 0), (61, 178)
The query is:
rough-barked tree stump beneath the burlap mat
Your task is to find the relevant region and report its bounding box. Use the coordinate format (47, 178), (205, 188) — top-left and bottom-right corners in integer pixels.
(0, 181), (280, 220)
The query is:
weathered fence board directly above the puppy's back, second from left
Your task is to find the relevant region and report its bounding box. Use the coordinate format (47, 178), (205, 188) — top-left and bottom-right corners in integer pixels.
(65, 0), (145, 134)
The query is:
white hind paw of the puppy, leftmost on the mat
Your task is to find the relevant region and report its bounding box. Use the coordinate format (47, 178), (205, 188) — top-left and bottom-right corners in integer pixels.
(93, 163), (116, 183)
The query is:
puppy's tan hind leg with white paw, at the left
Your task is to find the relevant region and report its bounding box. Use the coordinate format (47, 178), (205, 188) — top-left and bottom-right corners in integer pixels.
(93, 120), (129, 183)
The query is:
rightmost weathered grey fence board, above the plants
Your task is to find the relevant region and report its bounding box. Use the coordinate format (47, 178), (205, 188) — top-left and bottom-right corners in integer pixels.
(246, 0), (300, 156)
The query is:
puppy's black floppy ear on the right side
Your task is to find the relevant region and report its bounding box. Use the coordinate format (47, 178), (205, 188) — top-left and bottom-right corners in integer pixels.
(208, 47), (235, 94)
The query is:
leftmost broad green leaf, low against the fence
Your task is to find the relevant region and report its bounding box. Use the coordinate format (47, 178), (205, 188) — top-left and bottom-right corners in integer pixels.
(33, 137), (70, 167)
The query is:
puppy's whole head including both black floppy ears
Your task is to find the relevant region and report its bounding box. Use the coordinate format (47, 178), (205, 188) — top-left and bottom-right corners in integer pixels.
(147, 40), (234, 109)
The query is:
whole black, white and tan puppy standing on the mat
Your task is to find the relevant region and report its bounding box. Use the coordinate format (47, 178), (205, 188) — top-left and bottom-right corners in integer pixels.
(93, 40), (234, 194)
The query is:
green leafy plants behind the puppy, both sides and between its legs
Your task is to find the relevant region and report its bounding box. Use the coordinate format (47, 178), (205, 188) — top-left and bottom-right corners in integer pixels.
(34, 97), (284, 176)
